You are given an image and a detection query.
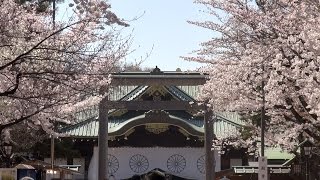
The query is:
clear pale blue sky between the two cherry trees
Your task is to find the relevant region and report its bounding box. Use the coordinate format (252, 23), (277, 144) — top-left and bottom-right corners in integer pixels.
(58, 0), (214, 71)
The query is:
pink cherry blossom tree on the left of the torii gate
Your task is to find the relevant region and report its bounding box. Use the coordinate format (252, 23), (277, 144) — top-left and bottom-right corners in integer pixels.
(0, 0), (130, 143)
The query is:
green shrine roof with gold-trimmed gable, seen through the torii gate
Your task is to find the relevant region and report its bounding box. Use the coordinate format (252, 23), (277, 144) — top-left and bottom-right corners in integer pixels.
(62, 68), (244, 138)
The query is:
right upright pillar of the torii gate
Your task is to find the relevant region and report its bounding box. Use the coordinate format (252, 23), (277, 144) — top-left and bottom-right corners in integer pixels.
(204, 107), (215, 180)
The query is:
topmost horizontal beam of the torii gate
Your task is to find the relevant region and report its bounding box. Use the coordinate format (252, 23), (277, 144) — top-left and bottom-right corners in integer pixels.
(111, 74), (206, 86)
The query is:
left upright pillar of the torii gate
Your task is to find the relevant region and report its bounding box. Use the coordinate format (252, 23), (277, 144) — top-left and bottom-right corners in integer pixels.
(98, 97), (108, 180)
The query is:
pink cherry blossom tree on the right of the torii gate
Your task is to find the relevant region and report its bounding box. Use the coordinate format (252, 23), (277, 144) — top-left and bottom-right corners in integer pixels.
(185, 0), (320, 150)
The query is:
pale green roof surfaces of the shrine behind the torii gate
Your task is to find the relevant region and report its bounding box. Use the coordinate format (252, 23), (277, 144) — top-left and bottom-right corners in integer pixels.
(62, 69), (243, 138)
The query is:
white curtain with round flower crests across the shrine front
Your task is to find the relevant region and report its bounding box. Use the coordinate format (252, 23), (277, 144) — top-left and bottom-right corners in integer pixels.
(88, 147), (221, 180)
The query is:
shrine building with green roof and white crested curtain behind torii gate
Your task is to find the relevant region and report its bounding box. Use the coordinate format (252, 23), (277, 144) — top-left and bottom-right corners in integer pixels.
(54, 68), (292, 180)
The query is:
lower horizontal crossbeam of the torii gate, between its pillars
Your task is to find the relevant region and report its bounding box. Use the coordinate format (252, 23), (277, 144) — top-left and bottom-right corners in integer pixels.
(106, 101), (202, 110)
